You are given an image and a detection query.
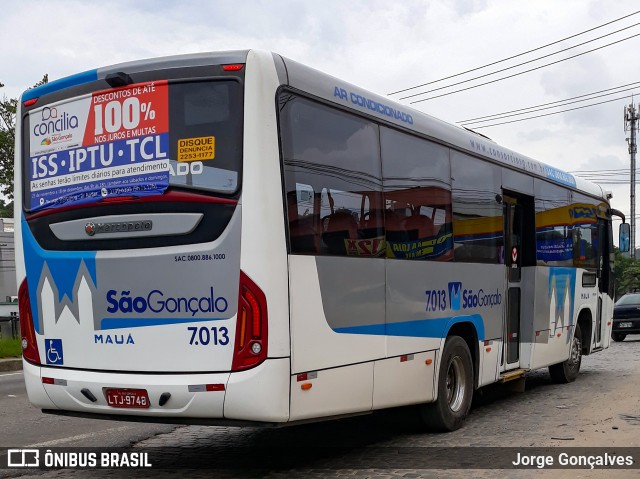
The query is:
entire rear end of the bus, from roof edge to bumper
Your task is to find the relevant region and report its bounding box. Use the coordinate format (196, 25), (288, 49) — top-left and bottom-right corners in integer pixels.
(15, 52), (290, 422)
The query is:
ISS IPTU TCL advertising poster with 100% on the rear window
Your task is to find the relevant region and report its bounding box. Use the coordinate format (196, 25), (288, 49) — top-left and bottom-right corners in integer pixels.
(26, 82), (169, 211)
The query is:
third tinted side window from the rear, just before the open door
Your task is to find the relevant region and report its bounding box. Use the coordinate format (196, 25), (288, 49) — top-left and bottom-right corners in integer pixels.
(451, 151), (504, 263)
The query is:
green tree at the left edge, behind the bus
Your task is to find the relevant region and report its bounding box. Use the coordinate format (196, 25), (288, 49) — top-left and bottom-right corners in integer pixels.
(0, 75), (49, 217)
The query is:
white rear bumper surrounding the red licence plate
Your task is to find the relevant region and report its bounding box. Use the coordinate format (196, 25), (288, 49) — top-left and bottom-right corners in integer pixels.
(23, 358), (290, 423)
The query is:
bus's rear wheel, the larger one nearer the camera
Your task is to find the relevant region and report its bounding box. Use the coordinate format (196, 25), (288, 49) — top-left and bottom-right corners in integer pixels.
(420, 336), (473, 431)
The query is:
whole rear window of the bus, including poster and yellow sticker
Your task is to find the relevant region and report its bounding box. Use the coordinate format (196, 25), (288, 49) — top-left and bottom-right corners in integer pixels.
(23, 80), (243, 211)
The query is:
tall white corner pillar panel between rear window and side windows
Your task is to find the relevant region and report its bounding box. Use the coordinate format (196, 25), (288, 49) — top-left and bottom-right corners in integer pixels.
(240, 50), (291, 357)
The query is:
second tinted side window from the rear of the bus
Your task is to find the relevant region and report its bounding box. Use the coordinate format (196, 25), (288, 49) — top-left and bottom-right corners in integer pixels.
(380, 127), (453, 261)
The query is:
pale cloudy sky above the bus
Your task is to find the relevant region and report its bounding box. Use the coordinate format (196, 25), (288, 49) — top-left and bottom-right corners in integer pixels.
(0, 0), (640, 245)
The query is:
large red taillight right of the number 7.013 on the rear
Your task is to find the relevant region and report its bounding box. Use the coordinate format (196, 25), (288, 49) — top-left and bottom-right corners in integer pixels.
(231, 271), (268, 371)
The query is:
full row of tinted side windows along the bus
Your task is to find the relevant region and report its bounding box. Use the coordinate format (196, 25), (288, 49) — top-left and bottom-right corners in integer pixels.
(279, 92), (592, 269)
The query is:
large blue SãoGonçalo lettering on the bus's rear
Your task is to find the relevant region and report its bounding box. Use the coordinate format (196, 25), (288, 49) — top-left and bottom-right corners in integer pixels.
(107, 286), (229, 316)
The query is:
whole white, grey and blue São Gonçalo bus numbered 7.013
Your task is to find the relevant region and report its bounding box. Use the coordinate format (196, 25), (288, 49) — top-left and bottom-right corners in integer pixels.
(15, 51), (626, 430)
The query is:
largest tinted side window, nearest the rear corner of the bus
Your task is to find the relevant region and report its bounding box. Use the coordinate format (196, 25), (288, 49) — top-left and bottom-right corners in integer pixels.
(280, 93), (384, 257)
